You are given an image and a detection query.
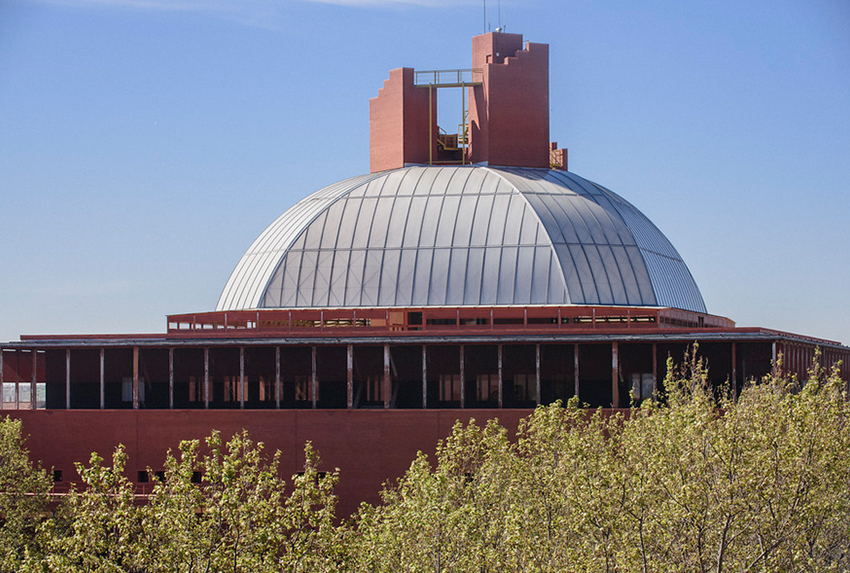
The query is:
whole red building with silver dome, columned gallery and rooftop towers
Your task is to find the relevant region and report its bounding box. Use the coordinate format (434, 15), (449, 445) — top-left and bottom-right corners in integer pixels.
(0, 33), (850, 513)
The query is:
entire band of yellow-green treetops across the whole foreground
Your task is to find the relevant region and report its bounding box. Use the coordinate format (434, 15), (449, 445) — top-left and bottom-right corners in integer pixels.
(0, 357), (850, 573)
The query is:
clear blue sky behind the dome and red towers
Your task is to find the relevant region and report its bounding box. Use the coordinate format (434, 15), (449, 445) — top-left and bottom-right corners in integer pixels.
(0, 0), (850, 344)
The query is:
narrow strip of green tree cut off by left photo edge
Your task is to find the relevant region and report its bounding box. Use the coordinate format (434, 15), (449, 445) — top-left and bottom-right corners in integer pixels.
(0, 417), (52, 572)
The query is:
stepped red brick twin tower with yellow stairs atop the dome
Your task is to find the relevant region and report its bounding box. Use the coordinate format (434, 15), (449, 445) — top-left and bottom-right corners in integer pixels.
(369, 32), (566, 173)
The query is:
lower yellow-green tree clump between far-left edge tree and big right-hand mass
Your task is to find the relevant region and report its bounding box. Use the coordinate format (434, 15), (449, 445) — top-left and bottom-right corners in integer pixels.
(29, 431), (345, 573)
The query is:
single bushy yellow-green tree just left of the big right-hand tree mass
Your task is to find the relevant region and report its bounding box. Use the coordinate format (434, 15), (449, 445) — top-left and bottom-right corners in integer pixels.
(143, 431), (341, 573)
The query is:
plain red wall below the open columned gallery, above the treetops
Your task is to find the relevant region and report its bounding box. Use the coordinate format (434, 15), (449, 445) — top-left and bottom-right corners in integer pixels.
(9, 410), (531, 517)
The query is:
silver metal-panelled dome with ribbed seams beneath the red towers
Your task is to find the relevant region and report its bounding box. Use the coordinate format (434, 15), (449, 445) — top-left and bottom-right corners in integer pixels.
(216, 166), (705, 312)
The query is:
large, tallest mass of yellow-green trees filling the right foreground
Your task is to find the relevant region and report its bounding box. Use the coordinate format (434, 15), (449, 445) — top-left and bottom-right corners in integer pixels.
(351, 358), (850, 572)
